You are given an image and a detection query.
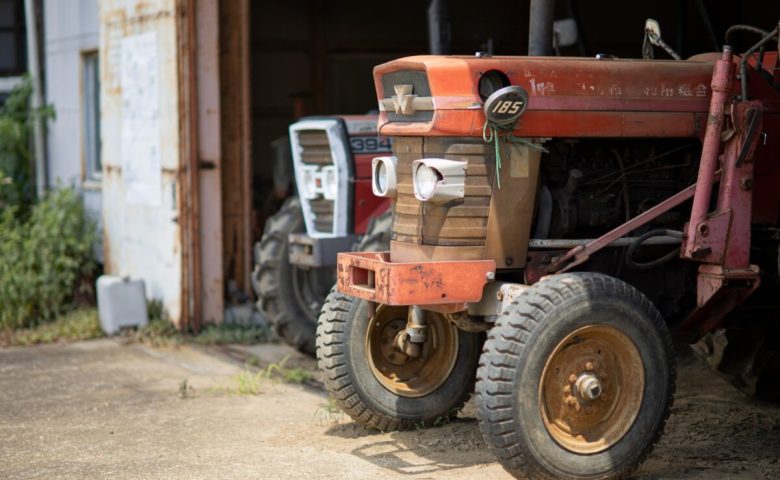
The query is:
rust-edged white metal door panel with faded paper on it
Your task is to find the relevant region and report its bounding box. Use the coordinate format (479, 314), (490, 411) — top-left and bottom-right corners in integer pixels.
(100, 0), (183, 323)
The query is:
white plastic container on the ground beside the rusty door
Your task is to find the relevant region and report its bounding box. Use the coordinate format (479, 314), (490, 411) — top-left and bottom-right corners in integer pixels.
(97, 275), (149, 335)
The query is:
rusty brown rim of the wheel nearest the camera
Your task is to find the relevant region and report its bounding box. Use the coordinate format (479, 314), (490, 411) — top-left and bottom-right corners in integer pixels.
(539, 325), (645, 454)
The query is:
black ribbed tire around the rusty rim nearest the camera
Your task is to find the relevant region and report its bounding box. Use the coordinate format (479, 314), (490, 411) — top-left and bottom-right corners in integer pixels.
(476, 273), (676, 479)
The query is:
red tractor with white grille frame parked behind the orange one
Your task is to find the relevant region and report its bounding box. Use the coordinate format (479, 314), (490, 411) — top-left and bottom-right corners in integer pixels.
(252, 115), (391, 355)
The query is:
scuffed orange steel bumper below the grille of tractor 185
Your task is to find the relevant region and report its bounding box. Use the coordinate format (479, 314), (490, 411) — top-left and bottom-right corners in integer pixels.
(337, 252), (496, 306)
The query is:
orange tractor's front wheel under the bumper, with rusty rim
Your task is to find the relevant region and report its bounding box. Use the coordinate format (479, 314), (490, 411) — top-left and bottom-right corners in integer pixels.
(317, 288), (481, 431)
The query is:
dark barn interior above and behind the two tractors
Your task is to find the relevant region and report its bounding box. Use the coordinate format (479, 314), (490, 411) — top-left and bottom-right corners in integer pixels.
(249, 0), (780, 236)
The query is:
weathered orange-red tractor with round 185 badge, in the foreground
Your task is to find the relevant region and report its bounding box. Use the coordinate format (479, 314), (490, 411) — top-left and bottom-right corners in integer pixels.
(317, 15), (780, 479)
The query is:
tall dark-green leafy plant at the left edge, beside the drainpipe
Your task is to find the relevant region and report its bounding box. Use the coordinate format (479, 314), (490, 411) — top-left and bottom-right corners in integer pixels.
(0, 77), (54, 215)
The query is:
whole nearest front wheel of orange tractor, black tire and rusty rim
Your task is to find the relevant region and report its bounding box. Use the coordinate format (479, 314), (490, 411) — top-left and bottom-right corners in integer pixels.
(476, 273), (675, 479)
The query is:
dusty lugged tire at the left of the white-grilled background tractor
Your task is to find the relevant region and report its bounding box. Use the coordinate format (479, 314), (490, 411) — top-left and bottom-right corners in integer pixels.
(252, 197), (335, 356)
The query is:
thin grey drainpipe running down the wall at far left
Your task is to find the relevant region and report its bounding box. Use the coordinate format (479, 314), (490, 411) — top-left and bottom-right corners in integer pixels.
(24, 0), (46, 198)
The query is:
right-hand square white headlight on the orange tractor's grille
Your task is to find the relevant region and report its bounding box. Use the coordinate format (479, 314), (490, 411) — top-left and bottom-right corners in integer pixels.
(412, 158), (468, 203)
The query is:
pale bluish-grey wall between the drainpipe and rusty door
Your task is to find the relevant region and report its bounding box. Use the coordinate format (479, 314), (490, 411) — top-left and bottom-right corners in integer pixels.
(43, 0), (103, 261)
